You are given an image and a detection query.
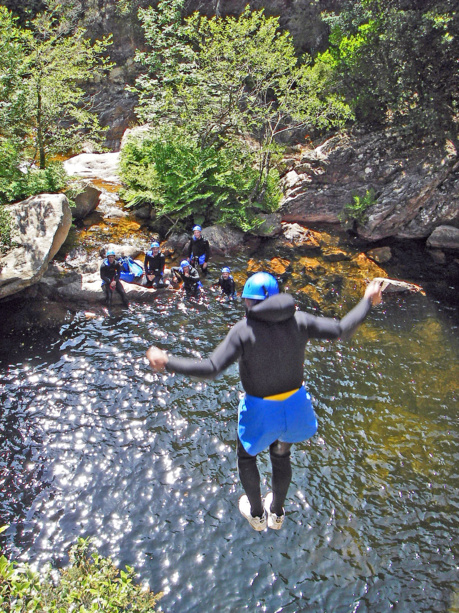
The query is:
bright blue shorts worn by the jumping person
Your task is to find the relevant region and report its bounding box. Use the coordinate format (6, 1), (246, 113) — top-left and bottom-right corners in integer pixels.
(238, 386), (317, 455)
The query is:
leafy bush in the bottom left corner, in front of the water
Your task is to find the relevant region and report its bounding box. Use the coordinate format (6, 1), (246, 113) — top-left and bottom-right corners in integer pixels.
(0, 538), (161, 613)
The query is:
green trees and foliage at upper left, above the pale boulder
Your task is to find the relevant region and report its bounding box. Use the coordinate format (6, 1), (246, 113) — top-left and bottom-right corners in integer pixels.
(0, 6), (109, 204)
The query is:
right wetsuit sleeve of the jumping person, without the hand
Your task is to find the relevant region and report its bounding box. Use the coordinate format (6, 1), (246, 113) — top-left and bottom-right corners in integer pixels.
(301, 298), (371, 340)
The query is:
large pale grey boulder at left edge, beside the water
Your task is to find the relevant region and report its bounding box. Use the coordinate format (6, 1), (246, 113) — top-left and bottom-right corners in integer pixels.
(0, 194), (72, 299)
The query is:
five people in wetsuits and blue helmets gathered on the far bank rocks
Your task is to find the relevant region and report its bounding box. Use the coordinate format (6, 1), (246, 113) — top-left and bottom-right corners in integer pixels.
(100, 225), (237, 306)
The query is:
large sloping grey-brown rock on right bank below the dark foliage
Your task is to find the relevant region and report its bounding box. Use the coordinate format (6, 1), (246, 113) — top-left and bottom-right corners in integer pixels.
(280, 132), (459, 241)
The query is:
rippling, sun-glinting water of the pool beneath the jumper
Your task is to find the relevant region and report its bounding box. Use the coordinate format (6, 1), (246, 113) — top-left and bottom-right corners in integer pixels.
(0, 255), (459, 613)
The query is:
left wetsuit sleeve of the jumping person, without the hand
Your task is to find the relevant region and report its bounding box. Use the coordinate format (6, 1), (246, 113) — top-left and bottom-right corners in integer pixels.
(166, 324), (242, 379)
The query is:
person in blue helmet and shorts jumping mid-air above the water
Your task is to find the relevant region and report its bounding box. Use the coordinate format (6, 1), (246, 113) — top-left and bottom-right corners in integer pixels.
(146, 272), (381, 531)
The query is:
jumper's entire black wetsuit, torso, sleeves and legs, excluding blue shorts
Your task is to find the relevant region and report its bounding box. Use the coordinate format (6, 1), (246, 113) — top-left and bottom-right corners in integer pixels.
(166, 294), (371, 516)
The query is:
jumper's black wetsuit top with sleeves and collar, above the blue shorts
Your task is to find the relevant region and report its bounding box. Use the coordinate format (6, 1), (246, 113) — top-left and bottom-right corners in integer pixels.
(166, 294), (370, 398)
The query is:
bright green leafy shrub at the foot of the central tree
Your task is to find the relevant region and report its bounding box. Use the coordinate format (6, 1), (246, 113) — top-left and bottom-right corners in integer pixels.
(121, 128), (280, 231)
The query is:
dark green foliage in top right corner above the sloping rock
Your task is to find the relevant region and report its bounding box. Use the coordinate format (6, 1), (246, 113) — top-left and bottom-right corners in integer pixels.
(317, 0), (459, 145)
